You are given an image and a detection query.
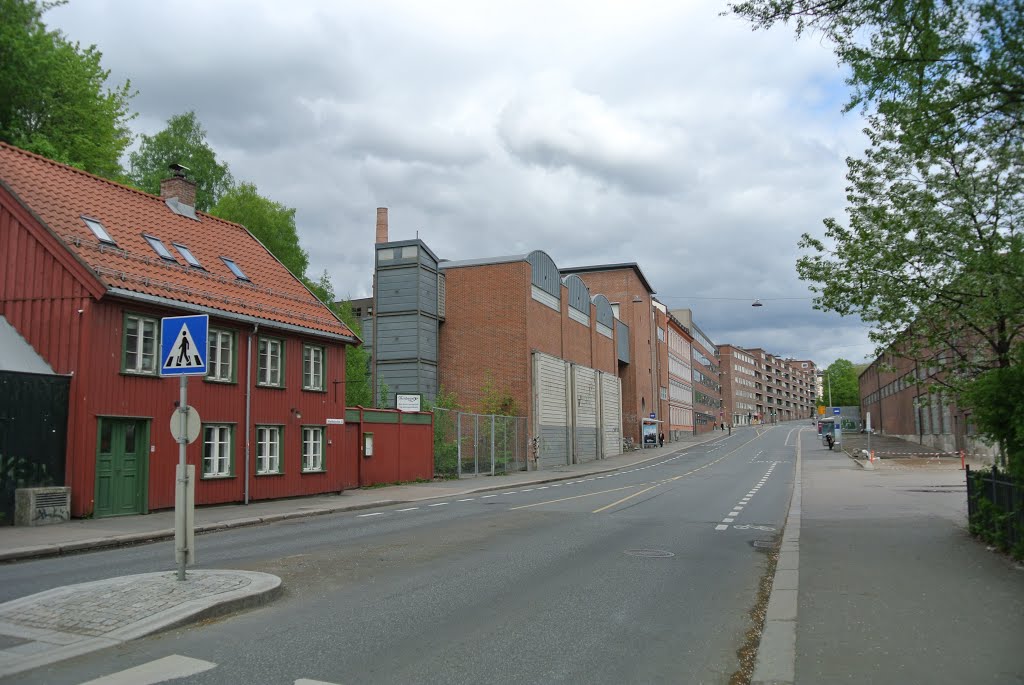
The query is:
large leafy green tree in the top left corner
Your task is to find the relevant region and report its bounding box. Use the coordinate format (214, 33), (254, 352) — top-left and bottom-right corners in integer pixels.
(0, 0), (135, 179)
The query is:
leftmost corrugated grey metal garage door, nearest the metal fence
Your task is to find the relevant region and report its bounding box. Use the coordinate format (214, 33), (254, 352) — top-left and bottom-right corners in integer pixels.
(534, 352), (569, 469)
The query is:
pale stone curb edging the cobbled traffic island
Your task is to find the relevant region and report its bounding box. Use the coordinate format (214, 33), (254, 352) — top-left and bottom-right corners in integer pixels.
(0, 570), (284, 678)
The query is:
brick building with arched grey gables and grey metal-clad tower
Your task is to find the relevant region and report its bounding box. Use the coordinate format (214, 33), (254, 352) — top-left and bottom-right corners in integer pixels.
(353, 213), (630, 468)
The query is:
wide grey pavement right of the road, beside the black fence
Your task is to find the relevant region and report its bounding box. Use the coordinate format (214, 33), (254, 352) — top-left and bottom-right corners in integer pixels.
(786, 440), (1024, 685)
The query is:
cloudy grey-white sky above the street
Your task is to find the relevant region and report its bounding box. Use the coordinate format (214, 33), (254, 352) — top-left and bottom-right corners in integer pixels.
(45, 0), (870, 365)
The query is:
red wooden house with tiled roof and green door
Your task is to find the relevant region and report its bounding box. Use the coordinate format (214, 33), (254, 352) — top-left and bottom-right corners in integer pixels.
(0, 143), (359, 516)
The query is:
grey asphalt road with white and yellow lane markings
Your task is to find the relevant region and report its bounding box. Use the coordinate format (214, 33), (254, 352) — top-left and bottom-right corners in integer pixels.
(0, 424), (801, 685)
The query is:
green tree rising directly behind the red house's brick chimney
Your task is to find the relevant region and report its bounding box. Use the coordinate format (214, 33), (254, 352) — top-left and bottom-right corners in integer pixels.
(129, 112), (233, 210)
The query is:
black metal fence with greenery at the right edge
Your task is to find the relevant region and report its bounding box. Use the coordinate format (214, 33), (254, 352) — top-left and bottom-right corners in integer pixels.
(967, 466), (1024, 558)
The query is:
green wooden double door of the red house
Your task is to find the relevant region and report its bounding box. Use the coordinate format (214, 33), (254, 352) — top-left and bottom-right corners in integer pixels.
(94, 419), (150, 518)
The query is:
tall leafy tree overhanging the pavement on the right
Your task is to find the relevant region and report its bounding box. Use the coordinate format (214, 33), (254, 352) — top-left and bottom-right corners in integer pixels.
(732, 0), (1024, 471)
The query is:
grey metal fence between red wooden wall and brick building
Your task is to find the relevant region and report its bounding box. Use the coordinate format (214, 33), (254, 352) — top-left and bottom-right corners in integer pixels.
(434, 408), (529, 478)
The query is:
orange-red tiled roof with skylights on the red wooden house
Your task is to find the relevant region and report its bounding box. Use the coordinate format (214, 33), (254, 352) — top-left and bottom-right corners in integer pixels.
(0, 142), (354, 338)
